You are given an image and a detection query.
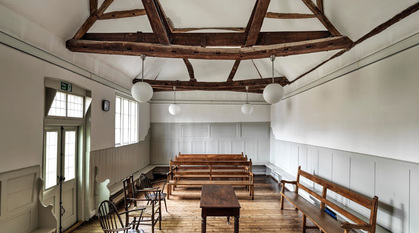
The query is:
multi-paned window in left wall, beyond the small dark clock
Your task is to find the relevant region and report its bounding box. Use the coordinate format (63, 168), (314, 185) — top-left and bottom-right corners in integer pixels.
(115, 96), (138, 146)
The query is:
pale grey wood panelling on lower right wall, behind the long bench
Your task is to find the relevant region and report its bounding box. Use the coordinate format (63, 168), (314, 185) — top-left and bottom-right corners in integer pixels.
(271, 140), (419, 233)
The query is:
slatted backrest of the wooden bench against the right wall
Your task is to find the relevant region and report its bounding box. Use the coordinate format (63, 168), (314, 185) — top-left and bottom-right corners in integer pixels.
(295, 166), (378, 232)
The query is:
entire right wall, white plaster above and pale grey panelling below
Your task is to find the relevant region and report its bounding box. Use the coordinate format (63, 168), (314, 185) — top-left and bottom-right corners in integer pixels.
(270, 39), (419, 233)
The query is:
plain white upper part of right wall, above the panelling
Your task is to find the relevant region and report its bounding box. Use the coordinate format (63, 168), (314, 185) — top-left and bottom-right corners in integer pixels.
(271, 46), (419, 163)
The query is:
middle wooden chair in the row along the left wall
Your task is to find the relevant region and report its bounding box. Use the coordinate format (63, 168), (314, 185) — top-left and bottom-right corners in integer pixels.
(122, 175), (162, 233)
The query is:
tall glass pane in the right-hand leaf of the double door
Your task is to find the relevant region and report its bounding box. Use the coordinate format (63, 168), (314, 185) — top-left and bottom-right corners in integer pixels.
(64, 131), (76, 181)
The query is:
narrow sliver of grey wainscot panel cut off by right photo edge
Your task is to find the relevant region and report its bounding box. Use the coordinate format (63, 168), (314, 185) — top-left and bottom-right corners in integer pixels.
(409, 165), (419, 233)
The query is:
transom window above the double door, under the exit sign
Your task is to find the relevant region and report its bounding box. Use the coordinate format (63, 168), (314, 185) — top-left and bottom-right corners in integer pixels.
(48, 92), (84, 118)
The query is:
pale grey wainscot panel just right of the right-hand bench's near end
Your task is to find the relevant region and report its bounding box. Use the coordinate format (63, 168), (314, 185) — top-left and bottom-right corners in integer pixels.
(376, 160), (410, 232)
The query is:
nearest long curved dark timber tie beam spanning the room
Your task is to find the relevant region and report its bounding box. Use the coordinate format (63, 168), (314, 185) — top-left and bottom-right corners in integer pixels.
(66, 36), (353, 60)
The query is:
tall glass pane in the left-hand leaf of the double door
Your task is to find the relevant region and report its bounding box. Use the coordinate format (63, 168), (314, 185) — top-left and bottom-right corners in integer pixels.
(45, 132), (58, 189)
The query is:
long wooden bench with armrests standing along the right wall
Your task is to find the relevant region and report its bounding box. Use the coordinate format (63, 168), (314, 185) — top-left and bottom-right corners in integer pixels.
(281, 167), (378, 233)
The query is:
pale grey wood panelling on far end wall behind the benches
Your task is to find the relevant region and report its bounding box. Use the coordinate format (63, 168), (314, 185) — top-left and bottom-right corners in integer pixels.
(151, 122), (270, 164)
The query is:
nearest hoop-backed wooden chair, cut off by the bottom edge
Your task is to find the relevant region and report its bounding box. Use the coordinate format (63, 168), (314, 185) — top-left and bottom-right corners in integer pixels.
(97, 200), (144, 233)
